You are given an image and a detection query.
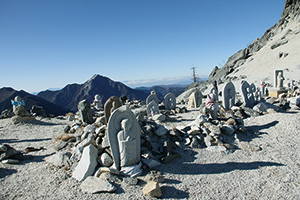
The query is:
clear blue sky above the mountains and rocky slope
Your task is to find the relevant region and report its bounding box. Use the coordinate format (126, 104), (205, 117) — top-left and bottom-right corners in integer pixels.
(0, 0), (284, 92)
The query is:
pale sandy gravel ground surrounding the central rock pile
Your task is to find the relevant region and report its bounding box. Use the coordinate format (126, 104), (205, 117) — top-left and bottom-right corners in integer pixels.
(0, 105), (300, 199)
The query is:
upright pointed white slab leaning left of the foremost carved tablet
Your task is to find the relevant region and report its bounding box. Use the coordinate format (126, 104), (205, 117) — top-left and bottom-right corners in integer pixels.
(72, 144), (98, 181)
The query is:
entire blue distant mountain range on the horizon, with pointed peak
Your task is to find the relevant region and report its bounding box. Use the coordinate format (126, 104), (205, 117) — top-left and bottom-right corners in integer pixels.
(0, 74), (190, 115)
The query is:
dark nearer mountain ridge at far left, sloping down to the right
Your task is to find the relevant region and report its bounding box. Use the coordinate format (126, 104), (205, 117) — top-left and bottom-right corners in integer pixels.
(0, 87), (69, 116)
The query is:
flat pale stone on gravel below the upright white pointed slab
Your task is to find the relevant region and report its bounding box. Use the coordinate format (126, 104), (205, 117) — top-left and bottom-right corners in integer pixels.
(80, 176), (117, 194)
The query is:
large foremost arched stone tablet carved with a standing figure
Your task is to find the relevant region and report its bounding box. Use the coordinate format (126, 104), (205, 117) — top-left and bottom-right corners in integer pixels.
(107, 105), (141, 171)
